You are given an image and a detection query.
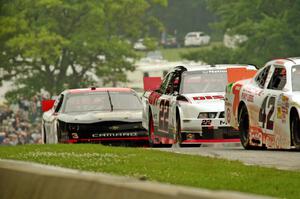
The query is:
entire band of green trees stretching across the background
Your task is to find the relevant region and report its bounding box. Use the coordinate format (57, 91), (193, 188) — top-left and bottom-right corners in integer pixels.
(0, 0), (300, 101)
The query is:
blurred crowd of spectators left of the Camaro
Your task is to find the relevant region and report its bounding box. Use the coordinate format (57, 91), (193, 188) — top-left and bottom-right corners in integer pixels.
(0, 97), (42, 146)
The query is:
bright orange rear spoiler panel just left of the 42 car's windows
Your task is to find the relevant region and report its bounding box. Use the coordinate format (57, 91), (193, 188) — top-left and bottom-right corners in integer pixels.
(227, 68), (257, 84)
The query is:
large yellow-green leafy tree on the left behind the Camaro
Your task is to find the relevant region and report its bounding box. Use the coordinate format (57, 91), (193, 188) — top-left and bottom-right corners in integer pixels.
(0, 0), (166, 102)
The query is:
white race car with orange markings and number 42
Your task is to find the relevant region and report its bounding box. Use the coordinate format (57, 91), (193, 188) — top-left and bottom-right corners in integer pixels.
(225, 58), (300, 149)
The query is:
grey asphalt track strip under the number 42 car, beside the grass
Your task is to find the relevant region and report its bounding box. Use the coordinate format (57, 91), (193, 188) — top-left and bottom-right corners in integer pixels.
(158, 144), (300, 171)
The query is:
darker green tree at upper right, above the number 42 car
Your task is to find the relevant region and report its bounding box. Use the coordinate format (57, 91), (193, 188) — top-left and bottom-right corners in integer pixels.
(182, 0), (300, 66)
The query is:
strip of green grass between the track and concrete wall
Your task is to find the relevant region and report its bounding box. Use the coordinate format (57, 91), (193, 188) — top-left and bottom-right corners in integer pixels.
(0, 144), (300, 198)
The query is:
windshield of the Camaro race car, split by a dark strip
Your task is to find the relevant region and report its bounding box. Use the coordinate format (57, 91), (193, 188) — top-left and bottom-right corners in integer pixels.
(64, 92), (142, 113)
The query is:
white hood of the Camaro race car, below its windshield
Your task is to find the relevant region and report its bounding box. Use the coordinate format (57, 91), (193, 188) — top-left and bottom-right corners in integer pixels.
(58, 110), (142, 123)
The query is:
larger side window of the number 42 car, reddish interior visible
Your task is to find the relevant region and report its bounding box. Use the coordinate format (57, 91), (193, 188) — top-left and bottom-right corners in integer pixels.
(268, 67), (286, 90)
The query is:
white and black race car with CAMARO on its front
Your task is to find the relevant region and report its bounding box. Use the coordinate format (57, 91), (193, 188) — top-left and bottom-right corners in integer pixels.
(42, 88), (148, 143)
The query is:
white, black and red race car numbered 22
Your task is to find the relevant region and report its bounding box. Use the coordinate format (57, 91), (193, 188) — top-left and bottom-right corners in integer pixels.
(142, 65), (256, 146)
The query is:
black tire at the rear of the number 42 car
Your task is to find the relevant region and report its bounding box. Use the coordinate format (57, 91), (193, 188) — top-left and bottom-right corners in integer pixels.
(239, 105), (252, 149)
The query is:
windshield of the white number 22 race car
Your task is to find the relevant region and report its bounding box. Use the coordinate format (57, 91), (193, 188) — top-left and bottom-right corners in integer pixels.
(180, 70), (227, 94)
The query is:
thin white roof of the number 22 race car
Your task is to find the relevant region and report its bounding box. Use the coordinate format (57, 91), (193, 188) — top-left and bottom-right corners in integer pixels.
(175, 64), (257, 71)
